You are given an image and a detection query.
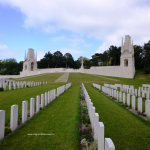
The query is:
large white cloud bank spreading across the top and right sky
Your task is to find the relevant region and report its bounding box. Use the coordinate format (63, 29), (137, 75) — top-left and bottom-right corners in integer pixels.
(0, 0), (150, 52)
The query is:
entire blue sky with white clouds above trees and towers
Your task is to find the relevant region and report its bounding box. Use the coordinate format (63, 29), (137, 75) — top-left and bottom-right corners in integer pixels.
(0, 0), (150, 62)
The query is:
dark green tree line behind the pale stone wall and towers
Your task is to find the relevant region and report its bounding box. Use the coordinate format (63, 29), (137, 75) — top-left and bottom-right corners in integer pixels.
(0, 41), (150, 75)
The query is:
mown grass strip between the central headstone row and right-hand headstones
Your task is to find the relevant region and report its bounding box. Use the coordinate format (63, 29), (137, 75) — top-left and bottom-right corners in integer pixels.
(85, 84), (150, 150)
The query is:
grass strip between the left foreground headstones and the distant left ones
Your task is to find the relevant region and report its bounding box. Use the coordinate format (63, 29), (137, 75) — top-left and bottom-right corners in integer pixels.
(0, 83), (63, 125)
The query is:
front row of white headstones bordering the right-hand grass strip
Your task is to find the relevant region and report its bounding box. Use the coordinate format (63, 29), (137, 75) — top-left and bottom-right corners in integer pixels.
(93, 83), (150, 117)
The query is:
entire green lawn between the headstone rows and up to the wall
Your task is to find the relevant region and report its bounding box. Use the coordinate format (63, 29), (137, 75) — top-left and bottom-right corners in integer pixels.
(0, 73), (150, 150)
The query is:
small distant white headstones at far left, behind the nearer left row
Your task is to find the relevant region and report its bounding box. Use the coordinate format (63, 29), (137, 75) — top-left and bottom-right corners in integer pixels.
(0, 80), (47, 91)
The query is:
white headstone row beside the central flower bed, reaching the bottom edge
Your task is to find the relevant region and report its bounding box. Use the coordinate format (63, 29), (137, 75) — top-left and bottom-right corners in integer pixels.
(82, 83), (115, 150)
